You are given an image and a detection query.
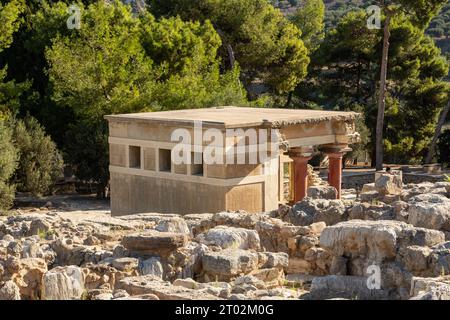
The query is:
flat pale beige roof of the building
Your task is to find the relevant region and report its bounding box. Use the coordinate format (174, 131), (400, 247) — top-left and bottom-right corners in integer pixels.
(105, 106), (359, 128)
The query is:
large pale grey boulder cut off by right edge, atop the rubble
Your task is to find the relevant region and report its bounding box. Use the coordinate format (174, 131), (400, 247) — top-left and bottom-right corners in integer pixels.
(408, 194), (450, 231)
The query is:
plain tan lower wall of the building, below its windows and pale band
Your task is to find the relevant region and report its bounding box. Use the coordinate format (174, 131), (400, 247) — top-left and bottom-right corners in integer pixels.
(111, 172), (272, 215)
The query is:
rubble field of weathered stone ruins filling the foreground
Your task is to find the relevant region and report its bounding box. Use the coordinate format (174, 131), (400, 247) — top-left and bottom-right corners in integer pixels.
(0, 174), (450, 300)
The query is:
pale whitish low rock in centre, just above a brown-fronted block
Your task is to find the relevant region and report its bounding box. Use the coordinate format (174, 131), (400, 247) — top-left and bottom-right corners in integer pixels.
(197, 226), (260, 250)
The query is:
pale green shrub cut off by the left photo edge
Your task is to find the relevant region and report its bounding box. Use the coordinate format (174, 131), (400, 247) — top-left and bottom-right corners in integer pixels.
(0, 120), (18, 211)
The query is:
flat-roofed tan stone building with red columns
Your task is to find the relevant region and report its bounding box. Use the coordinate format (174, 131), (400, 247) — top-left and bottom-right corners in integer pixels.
(106, 107), (358, 215)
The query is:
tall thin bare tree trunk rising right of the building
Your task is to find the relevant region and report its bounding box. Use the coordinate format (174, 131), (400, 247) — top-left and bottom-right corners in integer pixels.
(375, 12), (391, 170)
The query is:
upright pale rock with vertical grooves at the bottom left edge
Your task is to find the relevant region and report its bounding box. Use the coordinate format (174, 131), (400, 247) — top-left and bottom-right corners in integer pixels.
(42, 266), (84, 300)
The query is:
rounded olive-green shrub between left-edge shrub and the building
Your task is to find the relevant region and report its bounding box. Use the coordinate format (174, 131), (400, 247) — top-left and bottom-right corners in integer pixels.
(14, 116), (63, 196)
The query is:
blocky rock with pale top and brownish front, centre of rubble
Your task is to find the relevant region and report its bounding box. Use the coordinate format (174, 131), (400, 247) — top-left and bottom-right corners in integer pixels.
(202, 249), (259, 281)
